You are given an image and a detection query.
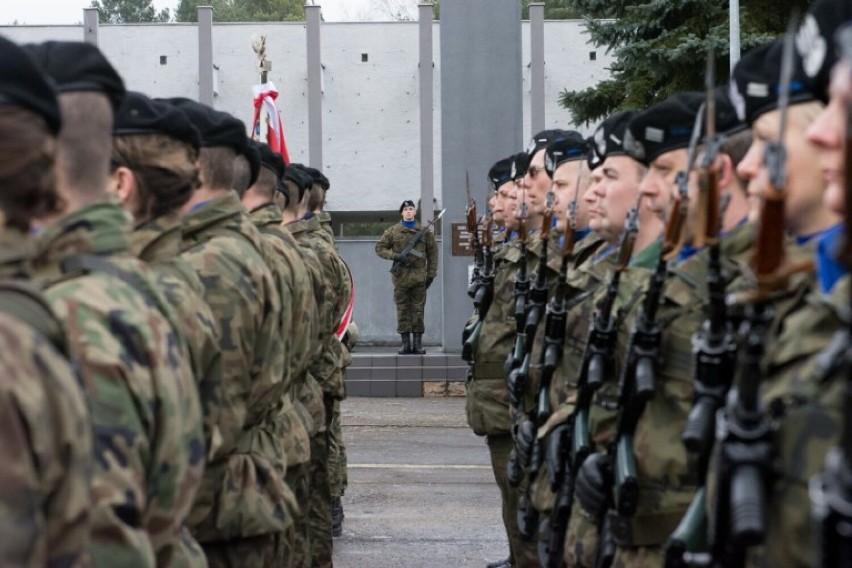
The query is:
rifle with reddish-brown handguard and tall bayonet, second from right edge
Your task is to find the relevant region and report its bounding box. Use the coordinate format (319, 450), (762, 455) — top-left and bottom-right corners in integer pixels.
(711, 21), (808, 568)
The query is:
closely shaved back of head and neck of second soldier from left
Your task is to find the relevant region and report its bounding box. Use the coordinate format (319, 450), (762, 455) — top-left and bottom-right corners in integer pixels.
(56, 91), (112, 200)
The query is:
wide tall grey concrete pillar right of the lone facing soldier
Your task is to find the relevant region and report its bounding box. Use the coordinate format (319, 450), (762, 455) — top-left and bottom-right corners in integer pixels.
(440, 0), (523, 353)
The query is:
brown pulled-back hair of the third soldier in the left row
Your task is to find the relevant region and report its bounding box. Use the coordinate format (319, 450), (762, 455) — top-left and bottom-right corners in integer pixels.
(111, 134), (200, 219)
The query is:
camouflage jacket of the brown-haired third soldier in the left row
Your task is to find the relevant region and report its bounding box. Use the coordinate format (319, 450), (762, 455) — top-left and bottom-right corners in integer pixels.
(130, 214), (222, 459)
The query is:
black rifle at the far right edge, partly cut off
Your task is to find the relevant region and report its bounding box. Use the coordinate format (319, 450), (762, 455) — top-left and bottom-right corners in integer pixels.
(809, 53), (852, 568)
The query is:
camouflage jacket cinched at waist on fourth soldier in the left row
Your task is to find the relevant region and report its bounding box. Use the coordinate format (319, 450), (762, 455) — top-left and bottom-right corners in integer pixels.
(181, 192), (295, 542)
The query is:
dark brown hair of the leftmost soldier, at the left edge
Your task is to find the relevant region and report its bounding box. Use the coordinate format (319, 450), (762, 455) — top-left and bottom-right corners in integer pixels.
(0, 106), (62, 231)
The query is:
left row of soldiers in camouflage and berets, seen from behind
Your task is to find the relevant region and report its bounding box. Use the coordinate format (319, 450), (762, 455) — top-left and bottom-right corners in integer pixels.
(0, 34), (353, 567)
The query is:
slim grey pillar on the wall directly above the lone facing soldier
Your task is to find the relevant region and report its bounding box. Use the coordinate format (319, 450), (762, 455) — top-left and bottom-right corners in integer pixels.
(418, 4), (435, 224)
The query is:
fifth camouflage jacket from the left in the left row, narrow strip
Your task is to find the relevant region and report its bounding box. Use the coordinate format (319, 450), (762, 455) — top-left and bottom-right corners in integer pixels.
(249, 203), (319, 466)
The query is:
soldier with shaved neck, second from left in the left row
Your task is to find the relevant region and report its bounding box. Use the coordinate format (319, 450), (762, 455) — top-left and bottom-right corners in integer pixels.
(23, 42), (204, 566)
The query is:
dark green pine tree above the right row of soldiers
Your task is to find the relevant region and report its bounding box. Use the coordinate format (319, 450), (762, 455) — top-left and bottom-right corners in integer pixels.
(559, 0), (810, 124)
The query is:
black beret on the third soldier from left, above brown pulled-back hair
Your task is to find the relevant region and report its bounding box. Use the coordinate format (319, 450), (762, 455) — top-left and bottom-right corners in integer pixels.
(112, 91), (201, 150)
